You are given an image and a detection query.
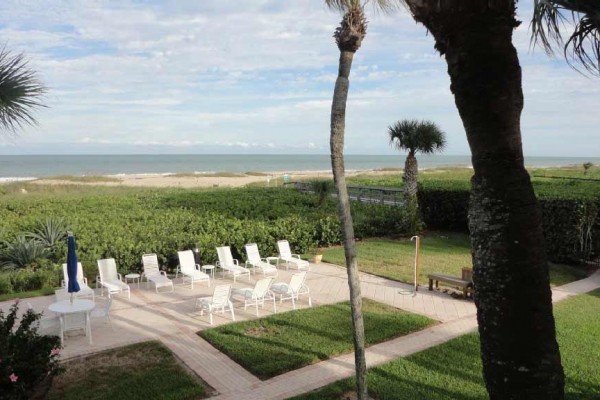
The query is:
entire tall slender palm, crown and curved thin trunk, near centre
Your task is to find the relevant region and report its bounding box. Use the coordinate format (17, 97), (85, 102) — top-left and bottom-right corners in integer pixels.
(325, 0), (392, 400)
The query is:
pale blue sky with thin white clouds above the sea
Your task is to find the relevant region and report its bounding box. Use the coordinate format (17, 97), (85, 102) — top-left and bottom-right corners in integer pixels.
(0, 0), (600, 157)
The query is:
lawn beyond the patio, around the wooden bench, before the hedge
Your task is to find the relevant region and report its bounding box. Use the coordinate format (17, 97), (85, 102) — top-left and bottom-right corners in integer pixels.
(323, 232), (586, 285)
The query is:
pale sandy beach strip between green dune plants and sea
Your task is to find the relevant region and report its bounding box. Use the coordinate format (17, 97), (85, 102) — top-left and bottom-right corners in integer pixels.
(31, 170), (401, 188)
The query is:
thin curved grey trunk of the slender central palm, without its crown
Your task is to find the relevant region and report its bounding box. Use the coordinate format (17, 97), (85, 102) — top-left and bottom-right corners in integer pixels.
(329, 50), (367, 400)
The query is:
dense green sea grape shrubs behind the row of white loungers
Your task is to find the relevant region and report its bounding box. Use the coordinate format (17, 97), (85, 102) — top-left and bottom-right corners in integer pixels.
(0, 188), (412, 293)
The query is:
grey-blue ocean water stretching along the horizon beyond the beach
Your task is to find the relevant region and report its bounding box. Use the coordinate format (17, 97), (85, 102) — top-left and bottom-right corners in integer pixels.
(0, 154), (600, 181)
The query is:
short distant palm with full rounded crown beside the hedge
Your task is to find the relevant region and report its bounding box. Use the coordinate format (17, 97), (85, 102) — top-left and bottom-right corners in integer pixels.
(388, 119), (446, 200)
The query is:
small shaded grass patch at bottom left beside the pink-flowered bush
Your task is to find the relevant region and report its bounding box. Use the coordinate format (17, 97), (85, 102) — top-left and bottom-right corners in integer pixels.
(49, 342), (207, 400)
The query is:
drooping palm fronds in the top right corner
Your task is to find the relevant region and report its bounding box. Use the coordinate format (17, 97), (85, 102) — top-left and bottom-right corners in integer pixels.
(530, 0), (600, 75)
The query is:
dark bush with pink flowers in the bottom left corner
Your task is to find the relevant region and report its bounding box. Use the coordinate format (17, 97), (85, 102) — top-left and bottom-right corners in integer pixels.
(0, 301), (61, 400)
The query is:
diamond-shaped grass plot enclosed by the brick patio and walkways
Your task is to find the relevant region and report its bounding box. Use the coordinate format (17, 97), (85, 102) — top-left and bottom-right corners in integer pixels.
(199, 299), (434, 379)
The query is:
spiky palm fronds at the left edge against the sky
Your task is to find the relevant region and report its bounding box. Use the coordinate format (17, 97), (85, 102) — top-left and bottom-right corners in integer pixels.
(0, 47), (46, 133)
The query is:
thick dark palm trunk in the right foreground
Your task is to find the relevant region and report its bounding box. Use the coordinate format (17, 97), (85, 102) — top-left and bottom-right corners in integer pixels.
(409, 0), (564, 400)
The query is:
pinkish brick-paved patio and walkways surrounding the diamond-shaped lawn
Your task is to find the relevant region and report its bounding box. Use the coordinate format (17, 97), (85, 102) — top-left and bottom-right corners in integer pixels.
(5, 263), (600, 400)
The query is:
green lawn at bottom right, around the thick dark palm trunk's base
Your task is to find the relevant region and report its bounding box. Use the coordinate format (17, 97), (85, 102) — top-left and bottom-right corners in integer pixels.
(295, 290), (600, 400)
